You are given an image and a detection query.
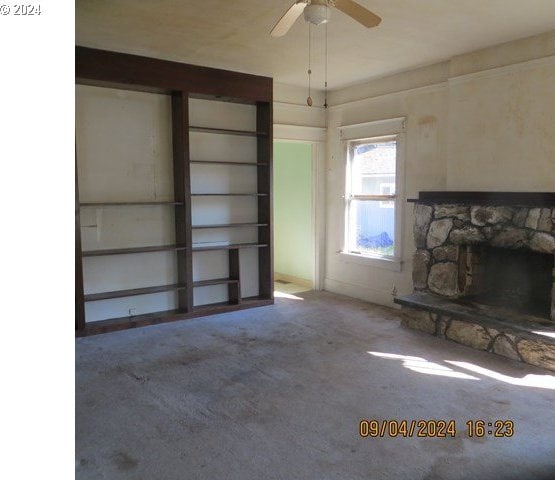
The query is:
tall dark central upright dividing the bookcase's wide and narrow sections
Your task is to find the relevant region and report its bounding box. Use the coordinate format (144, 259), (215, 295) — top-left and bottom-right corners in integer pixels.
(172, 91), (193, 313)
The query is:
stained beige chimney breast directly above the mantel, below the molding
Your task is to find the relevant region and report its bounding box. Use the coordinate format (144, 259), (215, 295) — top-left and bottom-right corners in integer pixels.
(445, 57), (555, 191)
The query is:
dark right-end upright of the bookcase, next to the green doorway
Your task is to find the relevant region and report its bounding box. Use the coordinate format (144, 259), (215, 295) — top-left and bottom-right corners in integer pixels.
(256, 99), (274, 300)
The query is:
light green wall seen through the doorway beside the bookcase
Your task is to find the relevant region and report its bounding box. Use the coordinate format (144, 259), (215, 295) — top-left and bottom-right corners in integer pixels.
(274, 142), (314, 281)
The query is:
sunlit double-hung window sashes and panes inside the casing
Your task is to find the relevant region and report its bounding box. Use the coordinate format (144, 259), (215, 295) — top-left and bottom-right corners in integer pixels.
(344, 135), (399, 259)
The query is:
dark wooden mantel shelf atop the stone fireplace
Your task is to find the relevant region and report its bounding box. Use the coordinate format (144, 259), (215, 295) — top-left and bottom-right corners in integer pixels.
(407, 191), (555, 207)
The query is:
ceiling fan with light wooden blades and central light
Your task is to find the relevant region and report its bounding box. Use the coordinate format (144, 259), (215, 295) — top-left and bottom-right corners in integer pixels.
(270, 0), (382, 37)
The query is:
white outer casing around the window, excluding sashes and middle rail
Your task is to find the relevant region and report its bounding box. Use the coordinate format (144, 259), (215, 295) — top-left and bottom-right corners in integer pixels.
(338, 117), (406, 272)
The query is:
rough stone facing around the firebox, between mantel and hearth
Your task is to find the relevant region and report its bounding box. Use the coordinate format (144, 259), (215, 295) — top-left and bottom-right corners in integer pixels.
(413, 204), (555, 320)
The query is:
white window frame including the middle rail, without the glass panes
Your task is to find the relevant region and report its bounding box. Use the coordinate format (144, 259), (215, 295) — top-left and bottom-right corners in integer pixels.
(338, 118), (405, 271)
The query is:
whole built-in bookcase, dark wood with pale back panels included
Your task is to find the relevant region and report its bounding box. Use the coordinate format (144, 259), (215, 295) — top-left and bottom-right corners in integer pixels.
(75, 47), (273, 336)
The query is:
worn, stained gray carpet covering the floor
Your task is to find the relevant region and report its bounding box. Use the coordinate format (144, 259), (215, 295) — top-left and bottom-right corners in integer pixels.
(76, 292), (555, 480)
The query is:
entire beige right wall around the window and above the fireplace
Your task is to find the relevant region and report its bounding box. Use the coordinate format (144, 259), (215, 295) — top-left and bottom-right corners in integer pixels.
(325, 32), (555, 305)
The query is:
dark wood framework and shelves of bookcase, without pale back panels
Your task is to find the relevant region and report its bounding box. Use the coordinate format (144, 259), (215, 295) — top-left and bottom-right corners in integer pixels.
(75, 47), (274, 336)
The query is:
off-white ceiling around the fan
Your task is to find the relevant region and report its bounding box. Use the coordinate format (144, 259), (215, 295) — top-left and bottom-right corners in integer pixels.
(76, 0), (555, 89)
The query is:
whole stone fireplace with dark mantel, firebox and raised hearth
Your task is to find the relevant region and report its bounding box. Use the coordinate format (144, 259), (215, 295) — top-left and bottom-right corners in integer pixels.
(395, 192), (555, 370)
